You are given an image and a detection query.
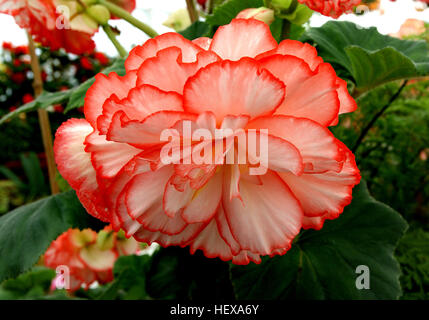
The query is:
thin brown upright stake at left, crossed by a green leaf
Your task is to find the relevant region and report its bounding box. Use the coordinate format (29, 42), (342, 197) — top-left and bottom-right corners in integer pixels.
(27, 33), (60, 194)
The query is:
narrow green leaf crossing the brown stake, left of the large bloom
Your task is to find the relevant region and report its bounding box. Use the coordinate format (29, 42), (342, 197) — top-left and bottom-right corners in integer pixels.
(0, 59), (125, 125)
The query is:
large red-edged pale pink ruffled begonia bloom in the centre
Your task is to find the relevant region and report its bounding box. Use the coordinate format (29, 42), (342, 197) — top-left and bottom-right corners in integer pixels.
(54, 19), (360, 264)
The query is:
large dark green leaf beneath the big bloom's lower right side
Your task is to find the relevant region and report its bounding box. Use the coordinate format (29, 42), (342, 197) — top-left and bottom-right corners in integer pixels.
(231, 182), (407, 299)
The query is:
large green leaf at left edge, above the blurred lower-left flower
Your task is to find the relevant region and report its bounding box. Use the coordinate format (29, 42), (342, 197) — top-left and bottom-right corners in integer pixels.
(0, 191), (98, 282)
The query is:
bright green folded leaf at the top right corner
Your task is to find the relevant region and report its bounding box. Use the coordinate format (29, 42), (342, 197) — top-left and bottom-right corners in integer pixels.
(301, 21), (429, 92)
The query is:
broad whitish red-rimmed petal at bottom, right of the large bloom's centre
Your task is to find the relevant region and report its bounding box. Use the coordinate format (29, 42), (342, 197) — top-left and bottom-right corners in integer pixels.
(222, 171), (303, 255)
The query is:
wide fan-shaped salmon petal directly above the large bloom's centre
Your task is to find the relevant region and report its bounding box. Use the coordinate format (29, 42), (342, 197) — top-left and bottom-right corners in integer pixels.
(183, 58), (285, 124)
